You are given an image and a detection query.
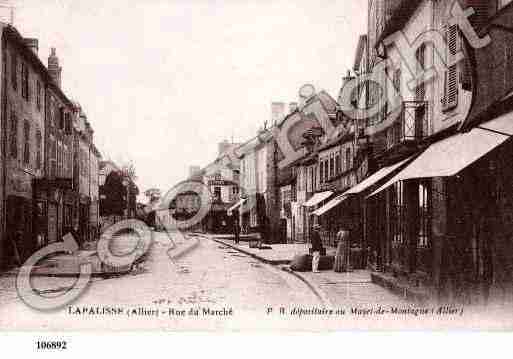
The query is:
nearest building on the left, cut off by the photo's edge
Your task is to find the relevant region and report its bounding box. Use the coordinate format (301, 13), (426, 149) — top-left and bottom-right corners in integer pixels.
(0, 24), (55, 266)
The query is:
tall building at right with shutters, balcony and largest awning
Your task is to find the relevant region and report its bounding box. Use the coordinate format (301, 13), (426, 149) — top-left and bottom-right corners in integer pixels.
(356, 0), (513, 303)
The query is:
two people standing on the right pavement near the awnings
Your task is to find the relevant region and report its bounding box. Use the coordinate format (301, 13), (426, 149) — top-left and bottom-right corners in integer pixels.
(311, 224), (350, 273)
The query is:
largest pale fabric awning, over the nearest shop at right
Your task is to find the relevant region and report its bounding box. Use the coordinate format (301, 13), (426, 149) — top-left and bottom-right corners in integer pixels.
(369, 113), (513, 197)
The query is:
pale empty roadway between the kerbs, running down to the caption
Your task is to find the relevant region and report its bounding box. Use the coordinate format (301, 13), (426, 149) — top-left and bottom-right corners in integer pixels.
(0, 234), (320, 330)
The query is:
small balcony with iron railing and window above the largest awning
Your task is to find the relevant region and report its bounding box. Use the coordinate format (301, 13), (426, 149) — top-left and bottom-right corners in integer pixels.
(387, 101), (428, 148)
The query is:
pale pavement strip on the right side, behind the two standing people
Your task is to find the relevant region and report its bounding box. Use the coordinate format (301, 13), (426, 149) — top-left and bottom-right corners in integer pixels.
(209, 235), (335, 265)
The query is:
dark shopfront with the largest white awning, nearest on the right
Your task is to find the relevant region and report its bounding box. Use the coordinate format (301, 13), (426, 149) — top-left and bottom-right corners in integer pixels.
(366, 113), (513, 303)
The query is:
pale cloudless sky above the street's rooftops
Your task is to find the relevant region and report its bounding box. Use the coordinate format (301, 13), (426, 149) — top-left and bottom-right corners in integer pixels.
(9, 0), (367, 201)
